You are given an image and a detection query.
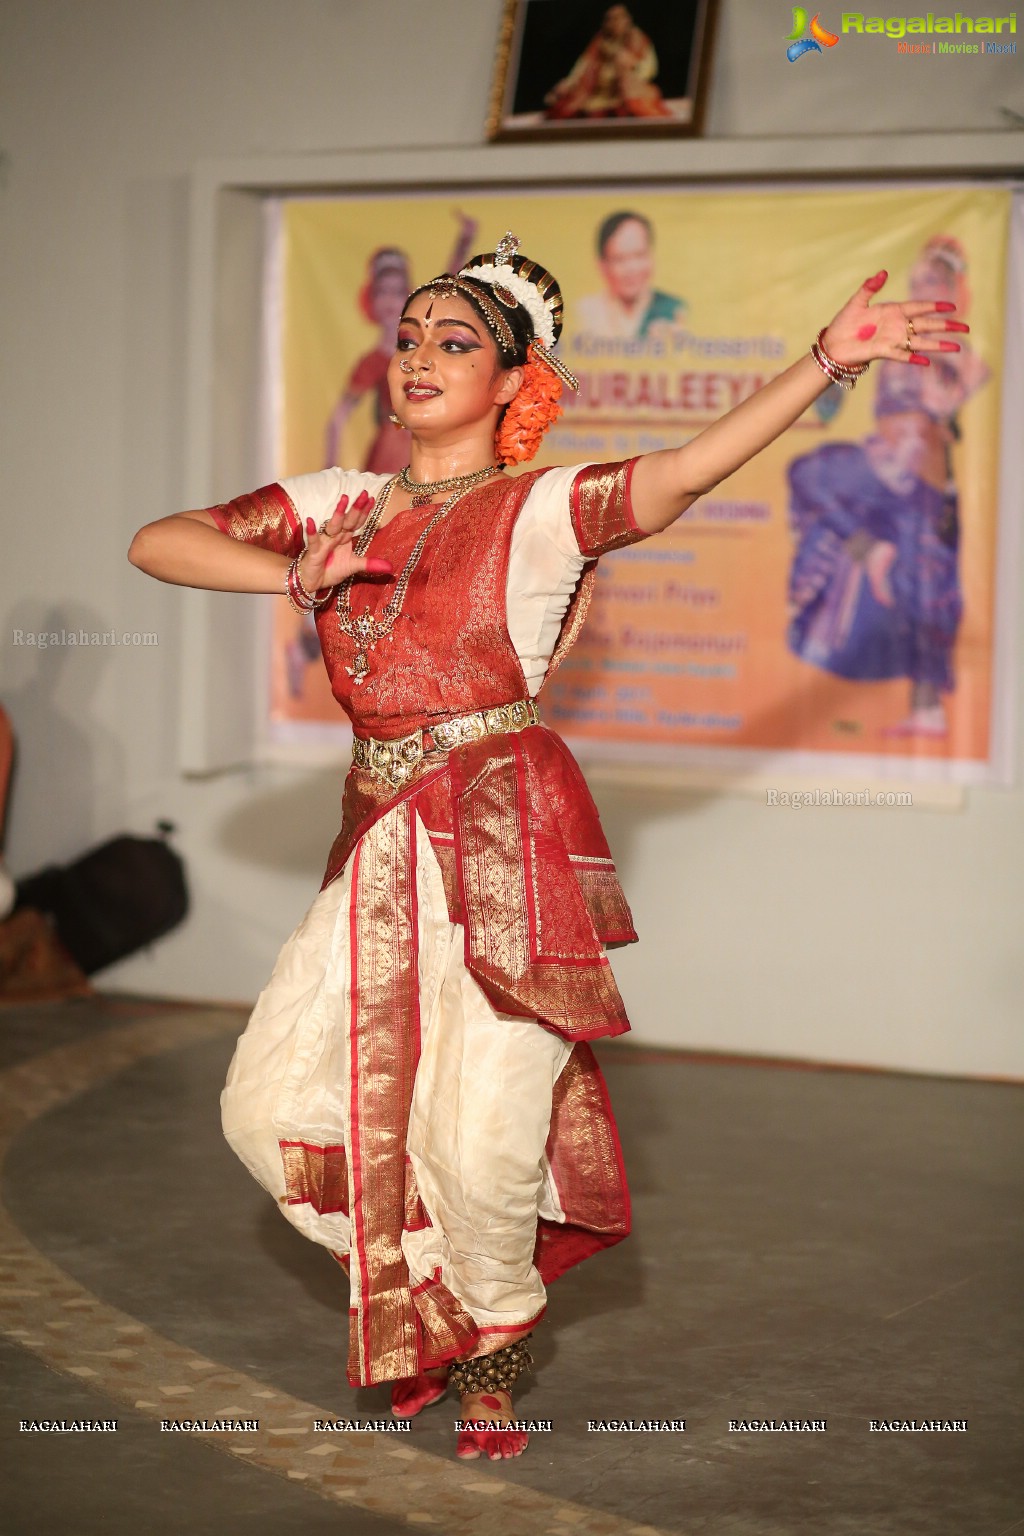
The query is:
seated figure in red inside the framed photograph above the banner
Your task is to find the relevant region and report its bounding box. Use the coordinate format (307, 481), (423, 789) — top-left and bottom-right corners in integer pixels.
(543, 5), (672, 120)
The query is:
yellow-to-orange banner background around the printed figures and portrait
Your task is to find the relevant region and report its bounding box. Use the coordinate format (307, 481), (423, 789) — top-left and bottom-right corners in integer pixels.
(270, 187), (1009, 763)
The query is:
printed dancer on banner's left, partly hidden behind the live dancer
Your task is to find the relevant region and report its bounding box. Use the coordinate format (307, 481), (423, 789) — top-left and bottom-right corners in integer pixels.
(284, 209), (477, 699)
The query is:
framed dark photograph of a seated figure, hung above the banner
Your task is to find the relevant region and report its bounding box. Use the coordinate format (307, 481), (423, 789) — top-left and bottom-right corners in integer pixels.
(487, 0), (717, 140)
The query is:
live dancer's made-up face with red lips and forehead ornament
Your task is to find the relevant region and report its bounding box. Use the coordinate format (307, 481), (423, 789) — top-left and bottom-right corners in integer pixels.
(387, 292), (522, 433)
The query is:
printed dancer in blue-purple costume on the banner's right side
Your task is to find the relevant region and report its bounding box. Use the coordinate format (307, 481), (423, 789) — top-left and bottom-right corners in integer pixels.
(788, 235), (989, 739)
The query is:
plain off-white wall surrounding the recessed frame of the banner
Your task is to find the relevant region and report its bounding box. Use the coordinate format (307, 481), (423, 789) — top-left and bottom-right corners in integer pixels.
(0, 0), (1024, 1074)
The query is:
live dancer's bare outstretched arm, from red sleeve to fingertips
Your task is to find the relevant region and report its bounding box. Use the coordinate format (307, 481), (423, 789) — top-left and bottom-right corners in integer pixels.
(631, 272), (970, 533)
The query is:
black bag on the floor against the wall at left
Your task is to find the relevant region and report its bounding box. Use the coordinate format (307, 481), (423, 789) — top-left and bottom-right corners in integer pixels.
(14, 822), (189, 975)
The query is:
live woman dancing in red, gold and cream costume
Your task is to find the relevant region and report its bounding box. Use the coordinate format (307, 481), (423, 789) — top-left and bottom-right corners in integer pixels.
(129, 235), (955, 1459)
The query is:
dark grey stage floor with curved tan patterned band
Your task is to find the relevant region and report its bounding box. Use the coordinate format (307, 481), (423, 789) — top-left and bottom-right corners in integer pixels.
(0, 994), (1024, 1536)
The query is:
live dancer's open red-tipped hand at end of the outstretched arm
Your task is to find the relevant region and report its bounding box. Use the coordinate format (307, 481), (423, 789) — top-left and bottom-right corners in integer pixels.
(821, 272), (970, 367)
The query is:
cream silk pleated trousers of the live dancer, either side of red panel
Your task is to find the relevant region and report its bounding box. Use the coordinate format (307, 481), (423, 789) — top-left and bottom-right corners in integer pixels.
(221, 811), (573, 1329)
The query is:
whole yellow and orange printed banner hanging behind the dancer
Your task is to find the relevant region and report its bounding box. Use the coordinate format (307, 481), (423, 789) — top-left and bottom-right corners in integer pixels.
(270, 186), (1024, 782)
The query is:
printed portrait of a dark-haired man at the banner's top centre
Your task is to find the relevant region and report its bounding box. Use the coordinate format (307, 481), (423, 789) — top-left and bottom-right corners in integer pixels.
(579, 209), (688, 341)
